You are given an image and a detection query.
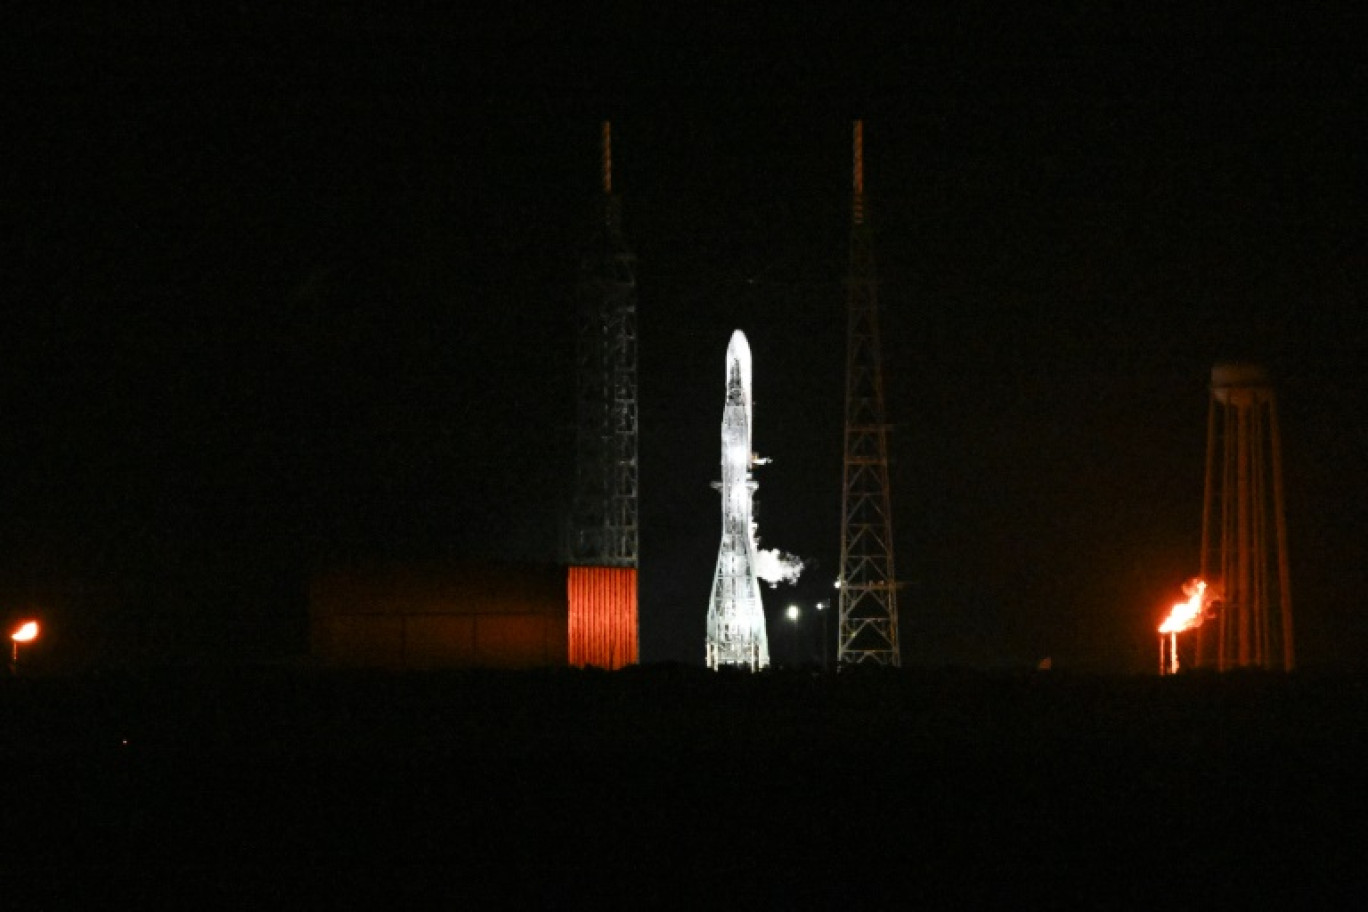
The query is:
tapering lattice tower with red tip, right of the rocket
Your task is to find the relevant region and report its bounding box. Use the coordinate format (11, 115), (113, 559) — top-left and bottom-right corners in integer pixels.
(836, 120), (902, 666)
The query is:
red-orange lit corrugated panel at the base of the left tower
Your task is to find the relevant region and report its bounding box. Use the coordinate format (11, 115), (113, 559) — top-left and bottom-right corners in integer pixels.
(568, 567), (636, 669)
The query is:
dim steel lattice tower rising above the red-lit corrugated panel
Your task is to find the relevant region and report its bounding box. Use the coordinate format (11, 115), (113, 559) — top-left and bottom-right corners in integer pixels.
(569, 122), (637, 567)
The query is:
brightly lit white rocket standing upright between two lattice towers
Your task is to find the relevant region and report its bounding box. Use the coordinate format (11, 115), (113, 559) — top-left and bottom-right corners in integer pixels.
(707, 330), (769, 671)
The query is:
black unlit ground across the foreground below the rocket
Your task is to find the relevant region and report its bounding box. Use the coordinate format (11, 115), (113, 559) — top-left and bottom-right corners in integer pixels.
(0, 666), (1368, 908)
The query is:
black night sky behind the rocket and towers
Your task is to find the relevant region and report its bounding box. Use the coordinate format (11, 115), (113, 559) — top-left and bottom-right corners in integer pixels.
(0, 4), (1368, 671)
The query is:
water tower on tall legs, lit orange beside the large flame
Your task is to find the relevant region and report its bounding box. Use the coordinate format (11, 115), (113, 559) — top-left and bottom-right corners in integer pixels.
(1197, 364), (1294, 671)
